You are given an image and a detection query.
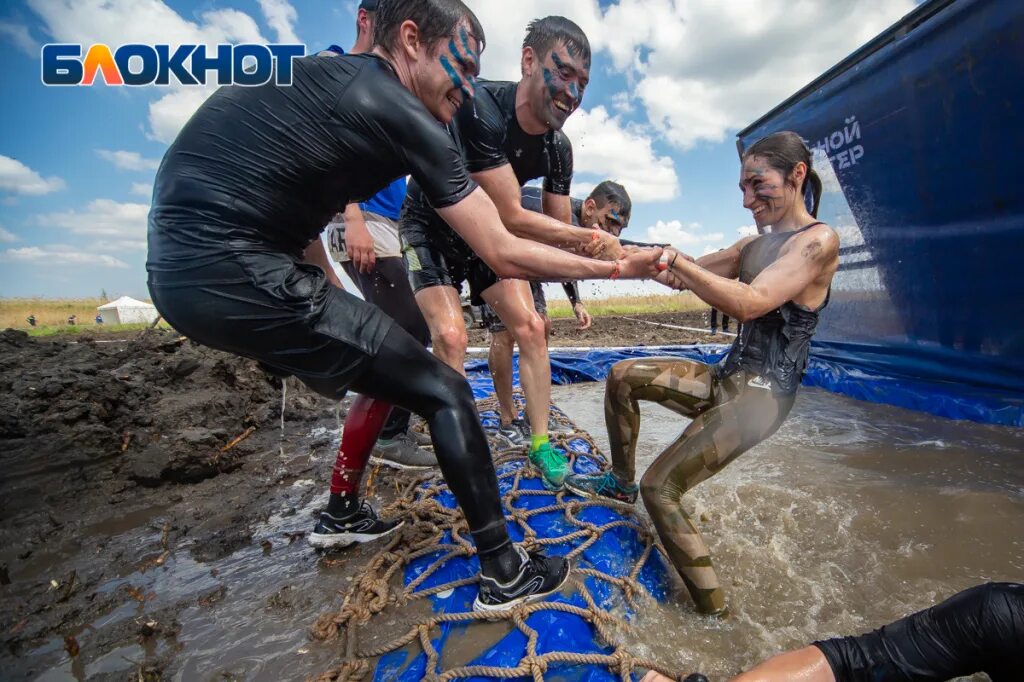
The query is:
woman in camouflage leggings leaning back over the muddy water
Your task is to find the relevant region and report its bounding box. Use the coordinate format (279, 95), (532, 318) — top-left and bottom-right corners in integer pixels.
(565, 132), (839, 613)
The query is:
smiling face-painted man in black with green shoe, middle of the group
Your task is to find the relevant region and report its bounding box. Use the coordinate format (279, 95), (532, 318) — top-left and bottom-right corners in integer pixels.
(400, 16), (623, 489)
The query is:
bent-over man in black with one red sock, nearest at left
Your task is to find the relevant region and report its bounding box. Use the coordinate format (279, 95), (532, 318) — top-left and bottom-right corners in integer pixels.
(146, 0), (662, 610)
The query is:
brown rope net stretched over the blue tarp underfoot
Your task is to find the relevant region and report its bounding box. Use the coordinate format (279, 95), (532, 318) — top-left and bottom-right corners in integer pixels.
(311, 397), (674, 682)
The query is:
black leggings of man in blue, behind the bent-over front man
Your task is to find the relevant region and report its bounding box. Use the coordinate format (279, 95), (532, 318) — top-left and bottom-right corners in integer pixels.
(341, 256), (430, 438)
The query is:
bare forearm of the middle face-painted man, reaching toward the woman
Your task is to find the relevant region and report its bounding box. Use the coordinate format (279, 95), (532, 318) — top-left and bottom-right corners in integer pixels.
(471, 164), (623, 260)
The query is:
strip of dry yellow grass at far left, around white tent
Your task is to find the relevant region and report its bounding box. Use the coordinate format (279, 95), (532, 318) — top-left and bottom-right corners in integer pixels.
(0, 298), (169, 336)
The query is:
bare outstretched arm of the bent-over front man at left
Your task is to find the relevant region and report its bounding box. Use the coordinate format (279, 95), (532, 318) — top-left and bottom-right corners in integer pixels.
(437, 187), (662, 282)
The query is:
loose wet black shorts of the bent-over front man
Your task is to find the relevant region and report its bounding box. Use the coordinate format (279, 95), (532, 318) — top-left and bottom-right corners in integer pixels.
(150, 245), (394, 398)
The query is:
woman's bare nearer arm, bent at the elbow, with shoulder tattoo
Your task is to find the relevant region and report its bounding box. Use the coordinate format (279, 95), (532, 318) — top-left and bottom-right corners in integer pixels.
(666, 225), (839, 323)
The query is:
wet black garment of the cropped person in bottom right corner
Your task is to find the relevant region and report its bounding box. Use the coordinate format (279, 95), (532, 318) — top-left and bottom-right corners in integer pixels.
(814, 583), (1024, 682)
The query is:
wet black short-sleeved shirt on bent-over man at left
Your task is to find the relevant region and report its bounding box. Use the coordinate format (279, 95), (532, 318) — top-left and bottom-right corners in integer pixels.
(146, 54), (476, 272)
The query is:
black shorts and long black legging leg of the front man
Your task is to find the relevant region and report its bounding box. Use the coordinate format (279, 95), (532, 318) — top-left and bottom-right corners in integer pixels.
(150, 251), (510, 557)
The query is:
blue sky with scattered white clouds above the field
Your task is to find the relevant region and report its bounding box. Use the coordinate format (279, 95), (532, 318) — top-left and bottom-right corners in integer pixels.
(0, 0), (914, 299)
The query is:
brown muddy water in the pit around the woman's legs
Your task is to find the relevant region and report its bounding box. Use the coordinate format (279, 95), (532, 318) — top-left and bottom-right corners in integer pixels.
(553, 384), (1024, 679)
